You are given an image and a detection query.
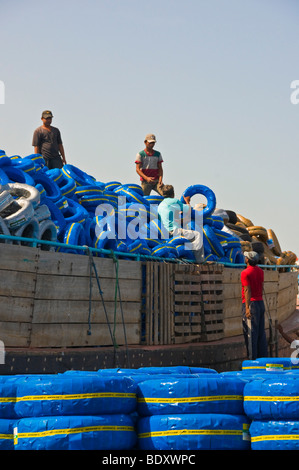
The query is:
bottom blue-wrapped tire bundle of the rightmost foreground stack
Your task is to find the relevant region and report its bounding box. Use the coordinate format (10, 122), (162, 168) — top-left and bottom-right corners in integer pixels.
(249, 420), (299, 450)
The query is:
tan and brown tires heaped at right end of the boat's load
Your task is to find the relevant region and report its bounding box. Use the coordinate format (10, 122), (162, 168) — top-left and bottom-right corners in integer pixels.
(216, 209), (297, 266)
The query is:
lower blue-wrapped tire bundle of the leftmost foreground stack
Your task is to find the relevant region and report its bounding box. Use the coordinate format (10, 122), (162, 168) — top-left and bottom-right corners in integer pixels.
(14, 415), (137, 450)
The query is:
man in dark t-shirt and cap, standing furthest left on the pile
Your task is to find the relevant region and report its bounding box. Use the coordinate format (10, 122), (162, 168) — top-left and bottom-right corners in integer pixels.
(32, 111), (66, 169)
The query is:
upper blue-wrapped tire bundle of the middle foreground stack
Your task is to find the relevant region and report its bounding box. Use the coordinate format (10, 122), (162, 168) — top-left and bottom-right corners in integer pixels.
(137, 374), (246, 416)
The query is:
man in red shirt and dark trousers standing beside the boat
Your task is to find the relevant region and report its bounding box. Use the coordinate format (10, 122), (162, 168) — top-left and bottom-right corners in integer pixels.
(241, 251), (268, 360)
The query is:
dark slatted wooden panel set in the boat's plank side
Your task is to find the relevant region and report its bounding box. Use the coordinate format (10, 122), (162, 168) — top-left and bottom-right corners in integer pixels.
(144, 262), (223, 345)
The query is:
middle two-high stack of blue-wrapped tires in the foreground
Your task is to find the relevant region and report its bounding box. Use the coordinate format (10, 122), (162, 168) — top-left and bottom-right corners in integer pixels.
(137, 374), (250, 450)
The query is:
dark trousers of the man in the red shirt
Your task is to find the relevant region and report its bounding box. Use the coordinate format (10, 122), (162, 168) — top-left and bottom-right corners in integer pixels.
(242, 300), (268, 360)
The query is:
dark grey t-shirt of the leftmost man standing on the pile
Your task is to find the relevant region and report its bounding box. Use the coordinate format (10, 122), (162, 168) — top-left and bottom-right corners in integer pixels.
(32, 126), (62, 158)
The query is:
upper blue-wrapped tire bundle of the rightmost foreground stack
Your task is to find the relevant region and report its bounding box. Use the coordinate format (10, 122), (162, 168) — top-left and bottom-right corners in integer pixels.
(244, 374), (299, 420)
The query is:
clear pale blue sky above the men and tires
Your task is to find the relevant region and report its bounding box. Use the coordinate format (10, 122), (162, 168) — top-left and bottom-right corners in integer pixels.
(0, 0), (299, 256)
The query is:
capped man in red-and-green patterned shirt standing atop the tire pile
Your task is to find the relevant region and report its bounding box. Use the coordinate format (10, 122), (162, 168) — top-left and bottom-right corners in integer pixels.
(135, 134), (163, 196)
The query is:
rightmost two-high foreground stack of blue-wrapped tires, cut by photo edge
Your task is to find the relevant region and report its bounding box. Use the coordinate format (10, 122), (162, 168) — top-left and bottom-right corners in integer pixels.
(244, 372), (299, 450)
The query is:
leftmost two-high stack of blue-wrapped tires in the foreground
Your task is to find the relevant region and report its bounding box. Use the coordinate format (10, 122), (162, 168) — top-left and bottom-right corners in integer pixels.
(0, 373), (137, 450)
